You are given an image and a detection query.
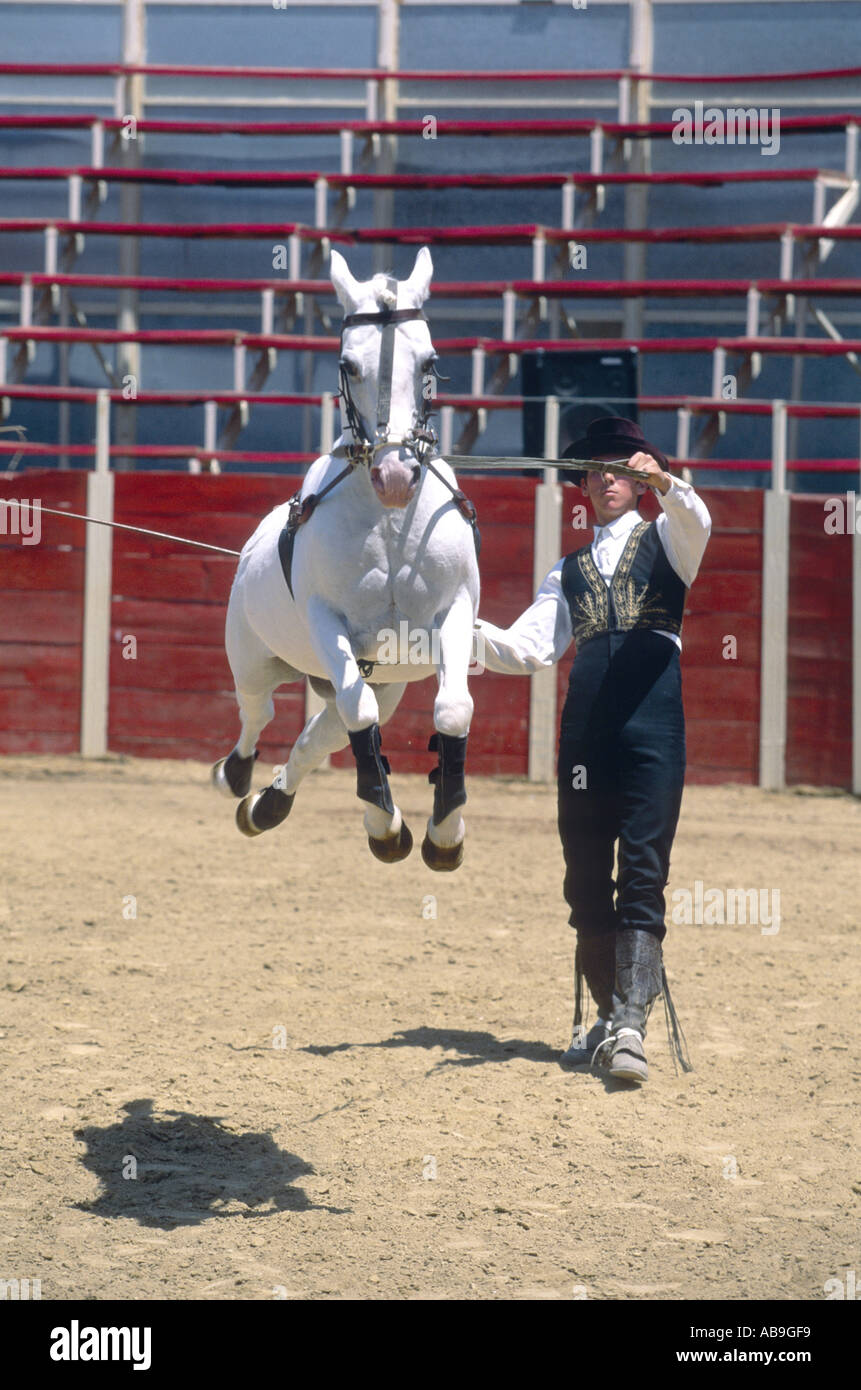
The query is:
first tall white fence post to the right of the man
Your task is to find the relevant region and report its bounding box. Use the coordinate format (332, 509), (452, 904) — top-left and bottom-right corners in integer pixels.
(759, 400), (791, 791)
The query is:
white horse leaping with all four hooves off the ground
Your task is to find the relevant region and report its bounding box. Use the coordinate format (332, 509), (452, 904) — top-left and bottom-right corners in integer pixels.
(213, 247), (478, 870)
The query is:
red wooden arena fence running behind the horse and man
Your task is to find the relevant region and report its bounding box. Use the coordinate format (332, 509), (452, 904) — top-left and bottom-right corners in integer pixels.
(0, 470), (851, 787)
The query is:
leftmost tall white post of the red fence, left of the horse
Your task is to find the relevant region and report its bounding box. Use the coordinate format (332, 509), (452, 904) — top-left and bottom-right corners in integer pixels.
(81, 391), (114, 758)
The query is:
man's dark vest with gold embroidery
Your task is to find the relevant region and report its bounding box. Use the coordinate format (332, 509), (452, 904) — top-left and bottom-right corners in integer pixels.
(562, 521), (687, 648)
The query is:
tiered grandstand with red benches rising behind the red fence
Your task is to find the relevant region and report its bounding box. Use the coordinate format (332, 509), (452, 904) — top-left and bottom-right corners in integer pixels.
(0, 6), (861, 790)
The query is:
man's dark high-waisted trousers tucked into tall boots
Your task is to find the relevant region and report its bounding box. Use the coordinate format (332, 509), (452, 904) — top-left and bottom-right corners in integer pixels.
(558, 631), (684, 941)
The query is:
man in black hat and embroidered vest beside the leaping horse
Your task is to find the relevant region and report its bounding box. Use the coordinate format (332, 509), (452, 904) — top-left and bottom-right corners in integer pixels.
(476, 417), (711, 1083)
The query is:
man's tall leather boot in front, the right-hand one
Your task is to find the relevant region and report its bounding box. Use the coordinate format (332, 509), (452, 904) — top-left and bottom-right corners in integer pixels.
(608, 929), (663, 1083)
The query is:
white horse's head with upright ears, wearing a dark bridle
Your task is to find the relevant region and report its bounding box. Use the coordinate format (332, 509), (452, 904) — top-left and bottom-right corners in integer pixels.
(331, 246), (437, 507)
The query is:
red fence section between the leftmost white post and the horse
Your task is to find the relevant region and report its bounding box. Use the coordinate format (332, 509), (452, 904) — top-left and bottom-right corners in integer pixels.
(108, 473), (305, 767)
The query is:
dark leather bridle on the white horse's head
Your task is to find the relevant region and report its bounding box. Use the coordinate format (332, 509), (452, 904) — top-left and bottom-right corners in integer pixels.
(335, 275), (438, 467)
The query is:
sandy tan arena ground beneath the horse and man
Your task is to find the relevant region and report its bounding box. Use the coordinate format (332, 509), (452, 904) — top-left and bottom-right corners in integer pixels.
(0, 758), (861, 1300)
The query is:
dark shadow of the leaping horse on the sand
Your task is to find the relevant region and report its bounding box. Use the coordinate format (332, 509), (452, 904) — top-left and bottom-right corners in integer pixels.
(75, 1099), (349, 1230)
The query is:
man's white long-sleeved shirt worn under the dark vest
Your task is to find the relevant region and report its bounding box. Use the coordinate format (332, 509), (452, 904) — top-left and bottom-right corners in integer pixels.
(474, 474), (712, 676)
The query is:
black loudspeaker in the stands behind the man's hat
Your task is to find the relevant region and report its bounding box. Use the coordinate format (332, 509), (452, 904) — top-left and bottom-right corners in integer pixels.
(520, 348), (638, 459)
